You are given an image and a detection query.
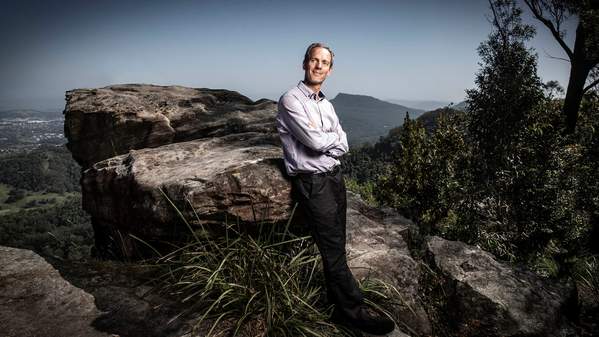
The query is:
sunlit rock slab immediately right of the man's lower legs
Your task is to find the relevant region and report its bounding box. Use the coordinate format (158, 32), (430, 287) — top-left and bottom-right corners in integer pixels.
(347, 192), (432, 336)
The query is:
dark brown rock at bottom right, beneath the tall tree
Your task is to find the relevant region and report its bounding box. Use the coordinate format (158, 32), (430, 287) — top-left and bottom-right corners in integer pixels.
(427, 237), (575, 336)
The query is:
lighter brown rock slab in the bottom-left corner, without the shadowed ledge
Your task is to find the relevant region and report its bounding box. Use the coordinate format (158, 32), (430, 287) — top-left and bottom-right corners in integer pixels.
(0, 246), (109, 337)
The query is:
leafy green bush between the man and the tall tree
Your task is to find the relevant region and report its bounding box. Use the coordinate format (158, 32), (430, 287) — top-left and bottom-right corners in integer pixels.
(374, 112), (469, 234)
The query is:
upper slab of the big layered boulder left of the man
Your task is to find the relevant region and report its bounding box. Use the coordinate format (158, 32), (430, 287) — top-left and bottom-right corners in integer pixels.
(64, 84), (276, 168)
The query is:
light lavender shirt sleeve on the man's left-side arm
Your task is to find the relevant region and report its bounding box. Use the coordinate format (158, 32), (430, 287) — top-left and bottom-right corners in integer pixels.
(279, 95), (341, 153)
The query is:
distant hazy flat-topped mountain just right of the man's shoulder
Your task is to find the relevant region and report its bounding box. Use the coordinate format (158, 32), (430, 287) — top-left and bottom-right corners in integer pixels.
(331, 93), (424, 145)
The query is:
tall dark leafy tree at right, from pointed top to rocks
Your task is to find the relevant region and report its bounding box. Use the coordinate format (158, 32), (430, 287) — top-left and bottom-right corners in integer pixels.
(454, 0), (592, 268)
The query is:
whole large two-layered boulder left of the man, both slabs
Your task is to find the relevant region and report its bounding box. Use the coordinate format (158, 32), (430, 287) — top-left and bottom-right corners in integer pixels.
(64, 84), (290, 258)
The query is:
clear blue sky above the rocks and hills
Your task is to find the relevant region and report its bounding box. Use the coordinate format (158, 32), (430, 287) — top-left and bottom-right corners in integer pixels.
(0, 0), (574, 109)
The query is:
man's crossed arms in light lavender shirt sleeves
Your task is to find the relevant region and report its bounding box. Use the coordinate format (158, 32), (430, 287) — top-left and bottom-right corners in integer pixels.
(279, 95), (349, 158)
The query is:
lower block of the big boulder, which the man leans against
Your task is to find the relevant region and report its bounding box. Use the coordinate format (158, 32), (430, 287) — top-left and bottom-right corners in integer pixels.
(82, 133), (291, 257)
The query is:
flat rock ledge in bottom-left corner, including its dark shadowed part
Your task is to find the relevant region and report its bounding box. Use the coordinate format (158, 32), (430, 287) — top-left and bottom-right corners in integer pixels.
(0, 246), (232, 337)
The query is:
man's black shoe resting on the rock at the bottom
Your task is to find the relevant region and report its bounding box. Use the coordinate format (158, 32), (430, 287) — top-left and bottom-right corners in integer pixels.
(331, 304), (395, 335)
